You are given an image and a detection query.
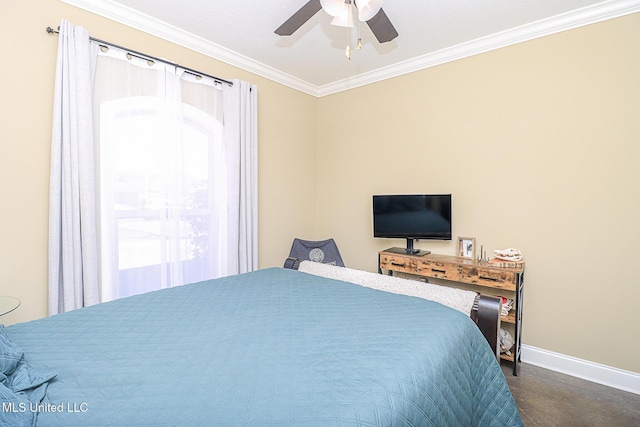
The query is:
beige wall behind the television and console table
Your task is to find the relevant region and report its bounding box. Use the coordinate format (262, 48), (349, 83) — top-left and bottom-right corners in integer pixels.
(316, 14), (640, 372)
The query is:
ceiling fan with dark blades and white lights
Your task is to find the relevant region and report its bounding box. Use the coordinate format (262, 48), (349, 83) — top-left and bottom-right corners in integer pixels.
(275, 0), (398, 43)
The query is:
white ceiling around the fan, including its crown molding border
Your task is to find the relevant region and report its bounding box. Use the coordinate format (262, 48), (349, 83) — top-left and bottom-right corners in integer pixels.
(61, 0), (640, 96)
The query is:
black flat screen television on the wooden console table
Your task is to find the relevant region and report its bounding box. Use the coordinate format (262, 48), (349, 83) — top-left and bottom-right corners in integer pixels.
(373, 194), (451, 254)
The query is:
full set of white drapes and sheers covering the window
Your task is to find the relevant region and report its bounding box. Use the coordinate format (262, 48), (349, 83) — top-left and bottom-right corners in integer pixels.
(49, 21), (258, 314)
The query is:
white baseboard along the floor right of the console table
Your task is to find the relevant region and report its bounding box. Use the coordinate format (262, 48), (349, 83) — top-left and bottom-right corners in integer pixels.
(520, 344), (640, 394)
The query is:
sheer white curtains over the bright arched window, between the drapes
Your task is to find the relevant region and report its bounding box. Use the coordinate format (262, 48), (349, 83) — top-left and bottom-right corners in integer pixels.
(94, 48), (257, 301)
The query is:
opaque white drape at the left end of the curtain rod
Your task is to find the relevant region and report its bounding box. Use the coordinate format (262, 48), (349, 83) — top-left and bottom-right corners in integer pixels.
(49, 20), (99, 315)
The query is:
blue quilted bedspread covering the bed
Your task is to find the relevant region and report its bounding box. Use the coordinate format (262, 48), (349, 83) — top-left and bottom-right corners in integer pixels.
(0, 268), (522, 427)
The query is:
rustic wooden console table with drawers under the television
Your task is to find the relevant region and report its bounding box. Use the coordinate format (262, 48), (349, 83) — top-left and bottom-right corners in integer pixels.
(378, 249), (524, 375)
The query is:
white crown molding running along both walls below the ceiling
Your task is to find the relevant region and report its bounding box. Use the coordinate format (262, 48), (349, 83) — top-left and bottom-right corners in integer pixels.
(60, 0), (640, 97)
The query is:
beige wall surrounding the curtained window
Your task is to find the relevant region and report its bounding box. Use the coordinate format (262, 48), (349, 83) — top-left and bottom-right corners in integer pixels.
(0, 0), (317, 324)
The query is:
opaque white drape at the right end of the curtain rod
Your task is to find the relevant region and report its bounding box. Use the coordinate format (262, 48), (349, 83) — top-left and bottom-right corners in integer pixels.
(224, 80), (258, 273)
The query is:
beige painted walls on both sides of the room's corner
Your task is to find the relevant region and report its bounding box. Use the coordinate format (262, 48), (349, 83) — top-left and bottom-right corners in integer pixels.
(0, 0), (640, 372)
